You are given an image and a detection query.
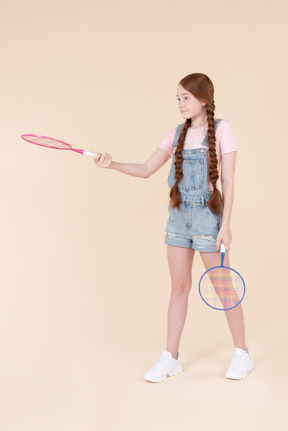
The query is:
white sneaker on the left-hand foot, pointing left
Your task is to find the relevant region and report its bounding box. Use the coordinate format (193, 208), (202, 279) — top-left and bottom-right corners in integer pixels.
(144, 350), (183, 383)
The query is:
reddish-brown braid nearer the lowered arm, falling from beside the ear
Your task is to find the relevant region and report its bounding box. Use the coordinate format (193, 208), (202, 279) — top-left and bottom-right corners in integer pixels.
(205, 100), (222, 216)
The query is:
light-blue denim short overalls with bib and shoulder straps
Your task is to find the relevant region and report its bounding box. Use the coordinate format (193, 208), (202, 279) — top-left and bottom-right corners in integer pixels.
(164, 118), (222, 252)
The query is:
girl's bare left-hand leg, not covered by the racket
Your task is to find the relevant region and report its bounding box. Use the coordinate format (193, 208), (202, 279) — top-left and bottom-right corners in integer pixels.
(166, 245), (195, 359)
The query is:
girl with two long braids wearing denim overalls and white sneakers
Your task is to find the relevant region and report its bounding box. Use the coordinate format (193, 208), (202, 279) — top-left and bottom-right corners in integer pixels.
(94, 73), (253, 382)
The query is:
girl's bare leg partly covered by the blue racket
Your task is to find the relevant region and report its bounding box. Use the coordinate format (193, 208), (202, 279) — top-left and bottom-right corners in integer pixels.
(200, 251), (248, 352)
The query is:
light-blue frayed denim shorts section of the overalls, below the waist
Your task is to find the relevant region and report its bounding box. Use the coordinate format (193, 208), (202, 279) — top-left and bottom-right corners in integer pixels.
(164, 195), (222, 252)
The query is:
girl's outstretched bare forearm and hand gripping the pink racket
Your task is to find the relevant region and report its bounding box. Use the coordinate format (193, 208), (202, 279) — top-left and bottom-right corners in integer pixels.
(94, 148), (170, 178)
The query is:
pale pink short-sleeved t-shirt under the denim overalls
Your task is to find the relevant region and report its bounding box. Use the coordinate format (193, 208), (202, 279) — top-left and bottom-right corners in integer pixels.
(157, 119), (238, 192)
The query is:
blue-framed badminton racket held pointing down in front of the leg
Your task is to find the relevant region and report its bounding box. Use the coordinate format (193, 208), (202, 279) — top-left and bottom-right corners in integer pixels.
(199, 242), (246, 310)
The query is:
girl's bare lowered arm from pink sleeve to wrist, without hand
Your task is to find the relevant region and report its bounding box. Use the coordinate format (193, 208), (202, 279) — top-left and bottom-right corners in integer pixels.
(221, 151), (237, 229)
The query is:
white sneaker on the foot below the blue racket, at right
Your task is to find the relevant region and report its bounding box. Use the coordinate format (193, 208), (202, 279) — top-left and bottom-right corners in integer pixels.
(225, 347), (254, 380)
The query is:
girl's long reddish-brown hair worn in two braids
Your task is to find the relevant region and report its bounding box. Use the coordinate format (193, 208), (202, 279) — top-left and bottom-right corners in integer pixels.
(170, 73), (222, 216)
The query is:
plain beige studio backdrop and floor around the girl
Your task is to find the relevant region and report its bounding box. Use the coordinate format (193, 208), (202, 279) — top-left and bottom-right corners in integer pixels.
(0, 0), (288, 431)
